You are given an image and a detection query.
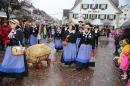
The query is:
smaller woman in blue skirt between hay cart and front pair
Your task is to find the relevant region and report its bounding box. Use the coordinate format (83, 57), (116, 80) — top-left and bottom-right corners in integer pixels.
(54, 26), (62, 52)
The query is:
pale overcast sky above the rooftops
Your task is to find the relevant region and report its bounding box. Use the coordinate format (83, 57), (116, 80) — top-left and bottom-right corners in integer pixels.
(33, 0), (130, 19)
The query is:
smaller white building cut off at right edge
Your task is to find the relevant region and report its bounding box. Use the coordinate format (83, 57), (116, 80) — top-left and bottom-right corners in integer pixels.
(119, 4), (130, 26)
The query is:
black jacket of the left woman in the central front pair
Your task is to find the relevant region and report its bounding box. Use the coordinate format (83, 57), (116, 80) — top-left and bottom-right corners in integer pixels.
(63, 30), (77, 43)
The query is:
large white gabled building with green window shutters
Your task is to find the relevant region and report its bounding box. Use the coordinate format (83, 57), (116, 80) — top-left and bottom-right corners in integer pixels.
(69, 0), (122, 28)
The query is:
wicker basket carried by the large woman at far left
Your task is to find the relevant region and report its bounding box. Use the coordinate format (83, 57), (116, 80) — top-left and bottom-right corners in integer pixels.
(11, 41), (25, 56)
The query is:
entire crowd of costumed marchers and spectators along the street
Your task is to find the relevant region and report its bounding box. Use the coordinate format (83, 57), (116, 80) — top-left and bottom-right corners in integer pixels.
(0, 19), (130, 84)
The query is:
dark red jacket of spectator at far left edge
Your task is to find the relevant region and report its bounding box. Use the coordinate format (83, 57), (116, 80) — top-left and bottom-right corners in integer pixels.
(1, 25), (11, 41)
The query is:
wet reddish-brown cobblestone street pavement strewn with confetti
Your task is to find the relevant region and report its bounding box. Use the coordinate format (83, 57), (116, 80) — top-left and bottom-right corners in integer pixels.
(0, 37), (124, 86)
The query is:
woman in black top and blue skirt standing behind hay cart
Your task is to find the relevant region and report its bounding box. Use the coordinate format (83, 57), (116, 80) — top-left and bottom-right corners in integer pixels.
(30, 21), (39, 46)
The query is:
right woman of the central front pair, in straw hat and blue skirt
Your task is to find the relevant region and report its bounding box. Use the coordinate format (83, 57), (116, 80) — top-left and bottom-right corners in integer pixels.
(76, 25), (93, 71)
